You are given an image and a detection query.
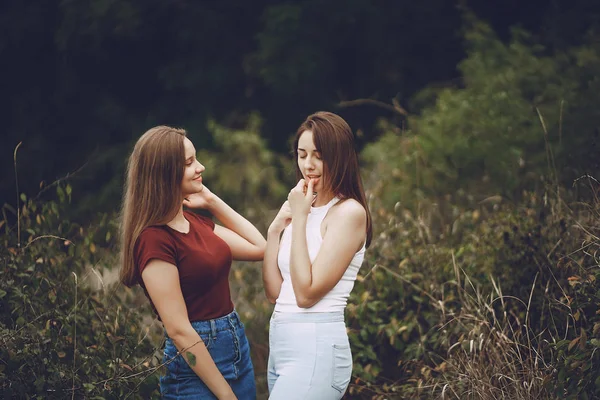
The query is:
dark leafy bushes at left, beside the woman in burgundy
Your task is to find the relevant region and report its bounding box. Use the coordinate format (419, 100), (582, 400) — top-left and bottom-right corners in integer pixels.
(0, 185), (158, 399)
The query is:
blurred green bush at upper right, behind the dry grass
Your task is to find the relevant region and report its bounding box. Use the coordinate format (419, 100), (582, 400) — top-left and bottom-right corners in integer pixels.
(364, 23), (600, 208)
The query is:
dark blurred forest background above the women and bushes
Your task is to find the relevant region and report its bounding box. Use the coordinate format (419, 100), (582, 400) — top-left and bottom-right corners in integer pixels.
(0, 0), (600, 216)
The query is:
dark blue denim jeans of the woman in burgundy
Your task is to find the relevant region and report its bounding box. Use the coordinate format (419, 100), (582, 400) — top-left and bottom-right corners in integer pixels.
(160, 311), (256, 400)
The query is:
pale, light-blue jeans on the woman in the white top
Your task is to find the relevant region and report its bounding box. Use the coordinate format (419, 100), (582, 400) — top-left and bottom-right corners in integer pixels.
(267, 312), (352, 400)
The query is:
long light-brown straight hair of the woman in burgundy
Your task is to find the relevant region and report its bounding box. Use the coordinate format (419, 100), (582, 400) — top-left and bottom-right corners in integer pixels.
(119, 126), (186, 287)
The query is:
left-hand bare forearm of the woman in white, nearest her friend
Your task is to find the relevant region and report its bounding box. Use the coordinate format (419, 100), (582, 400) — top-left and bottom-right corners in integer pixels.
(262, 201), (292, 304)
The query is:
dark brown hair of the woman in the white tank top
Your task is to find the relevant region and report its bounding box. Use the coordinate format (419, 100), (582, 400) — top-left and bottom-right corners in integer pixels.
(293, 111), (373, 247)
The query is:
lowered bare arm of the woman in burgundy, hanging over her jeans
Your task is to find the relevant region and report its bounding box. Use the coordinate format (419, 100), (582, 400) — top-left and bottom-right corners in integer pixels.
(142, 259), (236, 399)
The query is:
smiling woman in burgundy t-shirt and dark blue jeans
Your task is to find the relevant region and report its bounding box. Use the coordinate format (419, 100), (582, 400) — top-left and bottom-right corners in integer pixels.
(121, 126), (266, 399)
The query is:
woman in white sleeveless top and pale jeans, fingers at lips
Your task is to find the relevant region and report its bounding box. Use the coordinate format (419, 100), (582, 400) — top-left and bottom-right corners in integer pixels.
(263, 112), (372, 400)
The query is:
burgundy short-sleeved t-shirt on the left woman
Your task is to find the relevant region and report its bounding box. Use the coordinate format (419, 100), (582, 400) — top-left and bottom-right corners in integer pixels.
(134, 211), (233, 321)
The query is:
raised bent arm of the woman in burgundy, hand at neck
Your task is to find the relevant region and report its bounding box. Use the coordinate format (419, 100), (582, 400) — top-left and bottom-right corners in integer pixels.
(184, 186), (267, 261)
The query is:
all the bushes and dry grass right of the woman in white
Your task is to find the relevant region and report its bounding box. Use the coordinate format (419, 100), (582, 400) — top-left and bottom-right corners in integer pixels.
(348, 24), (600, 399)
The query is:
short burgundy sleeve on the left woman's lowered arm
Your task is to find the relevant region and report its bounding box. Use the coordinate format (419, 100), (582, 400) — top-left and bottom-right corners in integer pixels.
(133, 227), (177, 281)
